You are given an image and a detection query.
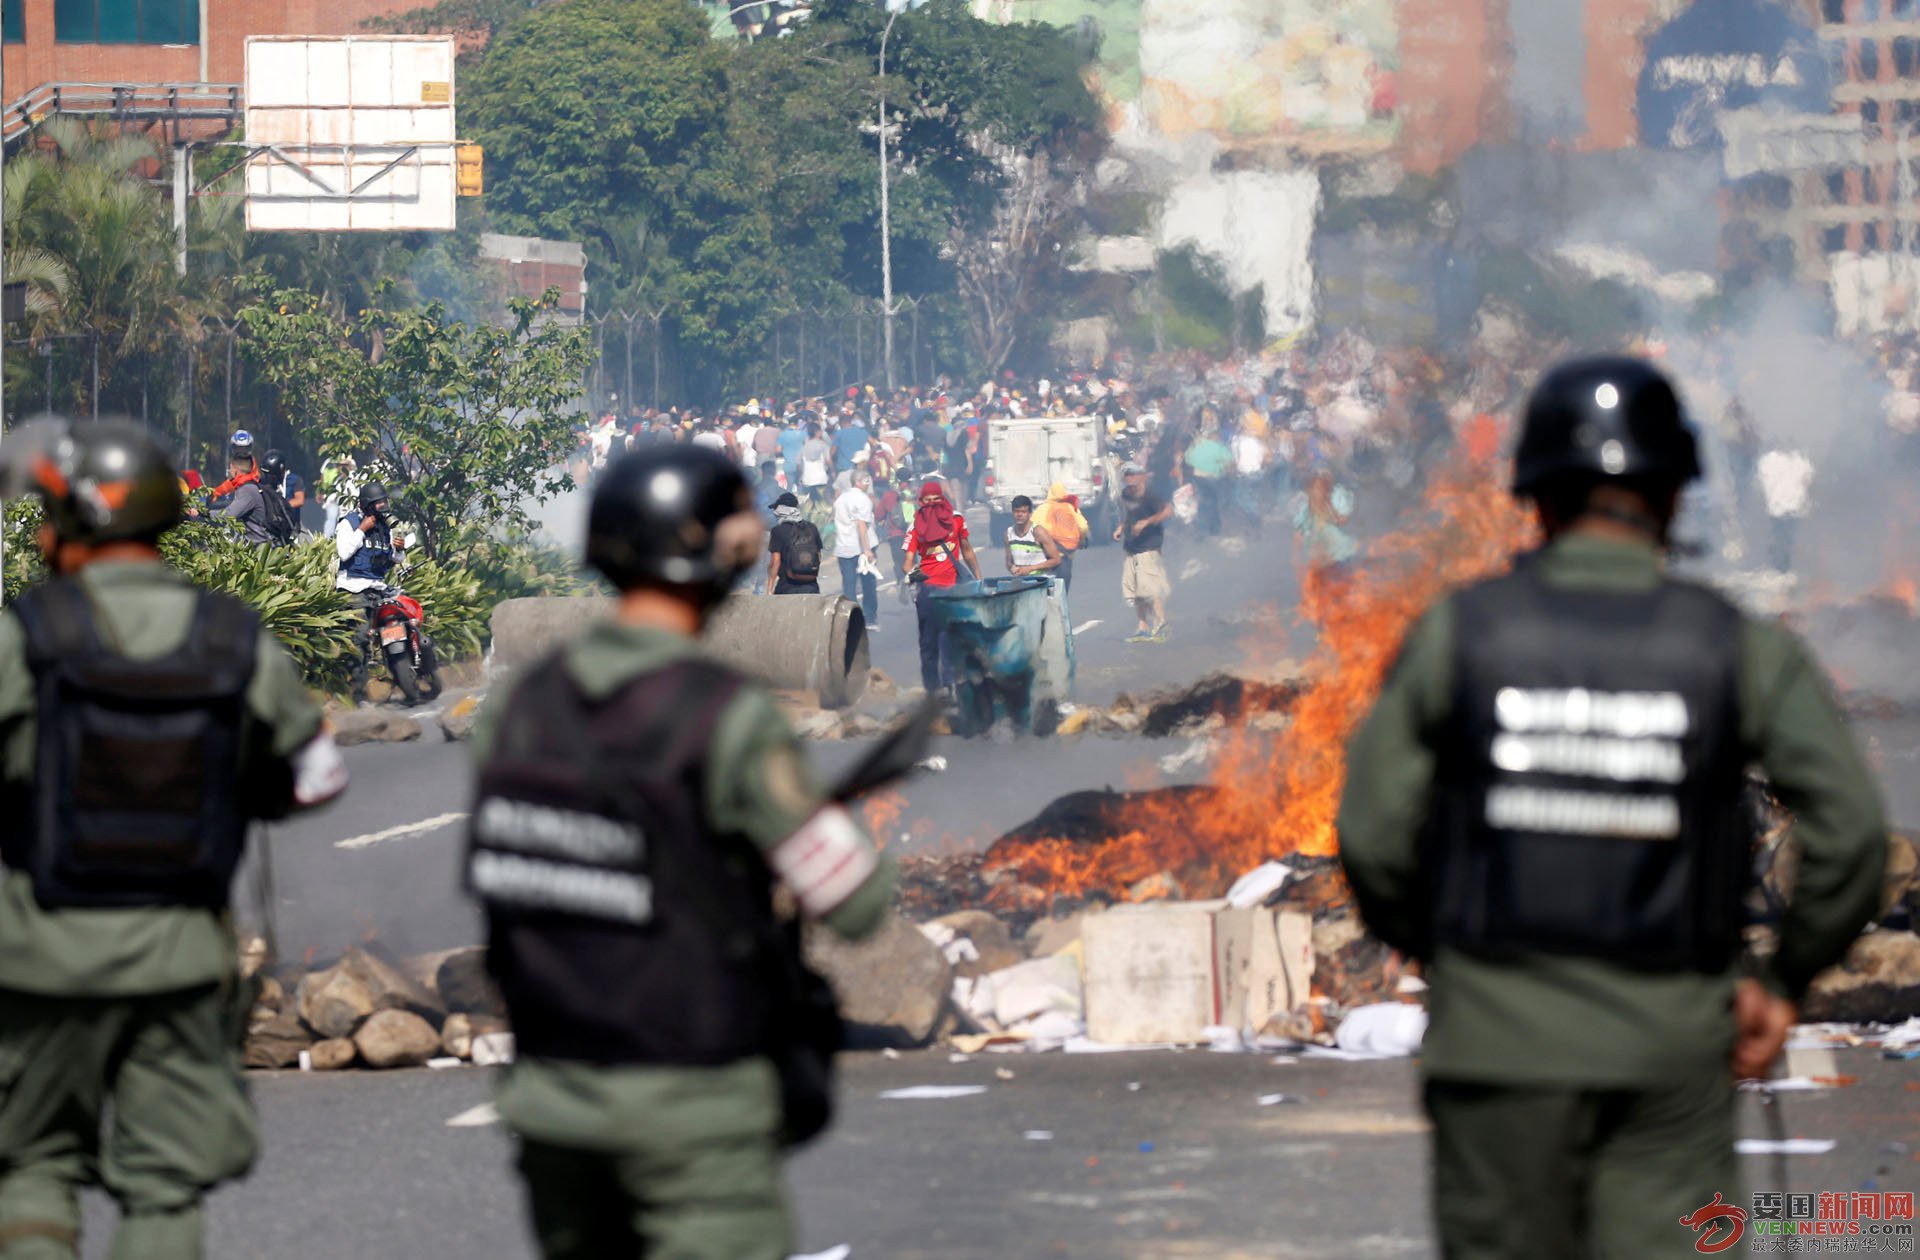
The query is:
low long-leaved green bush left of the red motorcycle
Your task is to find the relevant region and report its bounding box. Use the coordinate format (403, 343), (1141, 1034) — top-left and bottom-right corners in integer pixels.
(159, 521), (361, 693)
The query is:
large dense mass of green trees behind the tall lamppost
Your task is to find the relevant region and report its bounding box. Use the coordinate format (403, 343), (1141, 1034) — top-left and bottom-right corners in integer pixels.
(458, 0), (1100, 398)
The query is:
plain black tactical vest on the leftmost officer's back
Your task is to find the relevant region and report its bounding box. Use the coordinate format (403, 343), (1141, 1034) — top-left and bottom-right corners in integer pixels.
(8, 580), (259, 909)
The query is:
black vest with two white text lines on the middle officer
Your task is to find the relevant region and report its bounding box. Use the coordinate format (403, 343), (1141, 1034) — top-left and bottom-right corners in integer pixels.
(467, 655), (778, 1064)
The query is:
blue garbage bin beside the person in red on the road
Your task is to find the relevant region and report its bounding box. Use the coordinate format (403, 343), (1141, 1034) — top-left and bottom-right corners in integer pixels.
(933, 576), (1073, 736)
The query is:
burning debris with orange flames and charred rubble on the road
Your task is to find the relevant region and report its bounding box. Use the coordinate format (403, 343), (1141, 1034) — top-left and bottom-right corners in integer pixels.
(879, 426), (1530, 1031)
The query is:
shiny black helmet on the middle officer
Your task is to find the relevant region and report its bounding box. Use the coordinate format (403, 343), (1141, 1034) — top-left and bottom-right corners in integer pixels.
(586, 442), (758, 599)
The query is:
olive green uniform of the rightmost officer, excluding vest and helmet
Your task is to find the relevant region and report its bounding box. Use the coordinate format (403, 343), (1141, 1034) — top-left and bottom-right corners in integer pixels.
(1338, 536), (1887, 1260)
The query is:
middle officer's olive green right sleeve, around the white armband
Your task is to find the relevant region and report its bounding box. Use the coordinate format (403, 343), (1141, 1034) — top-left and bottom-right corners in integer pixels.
(707, 688), (897, 937)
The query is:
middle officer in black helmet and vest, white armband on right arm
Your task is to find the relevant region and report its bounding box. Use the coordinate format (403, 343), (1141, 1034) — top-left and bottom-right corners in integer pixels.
(467, 446), (893, 1260)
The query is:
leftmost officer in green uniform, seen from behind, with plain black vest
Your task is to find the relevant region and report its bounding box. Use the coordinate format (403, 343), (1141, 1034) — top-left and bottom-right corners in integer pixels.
(0, 423), (346, 1260)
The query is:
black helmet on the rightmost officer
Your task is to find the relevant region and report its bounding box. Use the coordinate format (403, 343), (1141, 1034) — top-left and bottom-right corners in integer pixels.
(1513, 355), (1699, 496)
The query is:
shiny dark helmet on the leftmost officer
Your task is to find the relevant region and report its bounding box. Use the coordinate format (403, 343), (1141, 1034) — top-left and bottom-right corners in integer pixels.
(0, 421), (182, 544)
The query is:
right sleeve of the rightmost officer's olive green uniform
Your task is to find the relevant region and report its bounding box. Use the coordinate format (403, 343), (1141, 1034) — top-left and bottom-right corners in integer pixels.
(1740, 620), (1887, 1001)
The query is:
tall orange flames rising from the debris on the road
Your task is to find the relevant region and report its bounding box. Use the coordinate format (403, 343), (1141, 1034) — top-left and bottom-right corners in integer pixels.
(989, 426), (1532, 899)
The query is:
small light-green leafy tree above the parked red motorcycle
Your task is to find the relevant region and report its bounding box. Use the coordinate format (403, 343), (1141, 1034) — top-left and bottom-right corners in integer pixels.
(240, 290), (591, 563)
